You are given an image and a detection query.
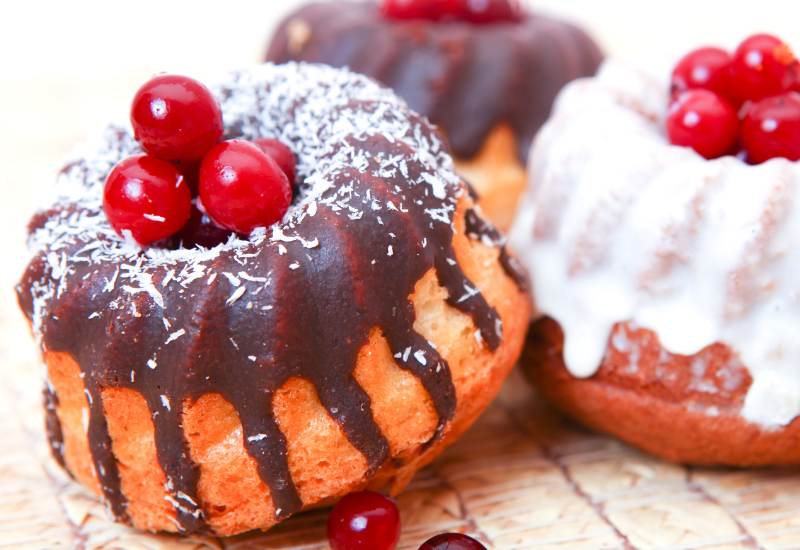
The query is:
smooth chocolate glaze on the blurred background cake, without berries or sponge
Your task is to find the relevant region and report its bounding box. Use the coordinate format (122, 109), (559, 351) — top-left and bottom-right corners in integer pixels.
(266, 0), (603, 164)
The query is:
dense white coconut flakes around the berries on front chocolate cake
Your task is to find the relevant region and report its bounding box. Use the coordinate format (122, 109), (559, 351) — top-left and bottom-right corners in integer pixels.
(29, 63), (461, 342)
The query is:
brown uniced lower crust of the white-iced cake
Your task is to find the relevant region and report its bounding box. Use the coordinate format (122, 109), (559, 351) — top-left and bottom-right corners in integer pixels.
(521, 317), (800, 466)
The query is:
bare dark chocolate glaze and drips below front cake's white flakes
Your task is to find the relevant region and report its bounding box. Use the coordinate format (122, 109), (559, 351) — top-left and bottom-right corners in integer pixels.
(17, 63), (520, 533)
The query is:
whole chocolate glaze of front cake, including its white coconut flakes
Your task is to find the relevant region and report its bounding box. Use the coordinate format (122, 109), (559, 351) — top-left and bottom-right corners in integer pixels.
(18, 65), (520, 532)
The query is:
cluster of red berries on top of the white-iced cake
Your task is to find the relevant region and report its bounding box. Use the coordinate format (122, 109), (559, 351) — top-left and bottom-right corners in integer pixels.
(666, 34), (800, 164)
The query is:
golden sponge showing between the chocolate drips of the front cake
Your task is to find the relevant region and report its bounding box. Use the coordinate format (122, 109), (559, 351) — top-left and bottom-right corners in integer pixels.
(45, 194), (530, 535)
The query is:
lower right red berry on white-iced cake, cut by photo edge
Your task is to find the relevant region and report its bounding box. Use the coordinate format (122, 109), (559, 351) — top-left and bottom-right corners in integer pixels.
(742, 92), (800, 164)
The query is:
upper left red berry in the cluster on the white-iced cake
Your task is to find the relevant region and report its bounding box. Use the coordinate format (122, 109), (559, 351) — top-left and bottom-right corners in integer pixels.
(672, 48), (741, 105)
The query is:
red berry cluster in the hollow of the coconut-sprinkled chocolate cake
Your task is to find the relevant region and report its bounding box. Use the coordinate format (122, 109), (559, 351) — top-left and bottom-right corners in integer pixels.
(103, 74), (296, 245)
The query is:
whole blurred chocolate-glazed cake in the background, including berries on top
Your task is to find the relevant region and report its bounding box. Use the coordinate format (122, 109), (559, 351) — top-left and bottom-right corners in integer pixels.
(267, 0), (602, 229)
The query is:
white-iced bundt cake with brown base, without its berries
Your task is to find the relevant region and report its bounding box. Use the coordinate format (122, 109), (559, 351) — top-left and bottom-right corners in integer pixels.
(509, 62), (800, 465)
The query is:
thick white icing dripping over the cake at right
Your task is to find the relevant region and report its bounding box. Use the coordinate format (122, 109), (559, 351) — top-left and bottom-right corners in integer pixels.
(509, 62), (800, 427)
